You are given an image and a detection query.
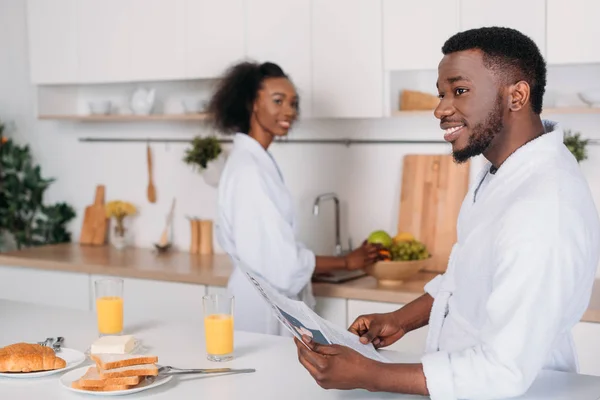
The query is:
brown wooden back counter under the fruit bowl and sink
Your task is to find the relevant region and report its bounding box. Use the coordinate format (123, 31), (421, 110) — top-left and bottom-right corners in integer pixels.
(0, 244), (600, 323)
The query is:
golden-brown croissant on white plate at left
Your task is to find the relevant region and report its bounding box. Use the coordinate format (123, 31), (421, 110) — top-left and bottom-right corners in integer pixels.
(0, 343), (67, 372)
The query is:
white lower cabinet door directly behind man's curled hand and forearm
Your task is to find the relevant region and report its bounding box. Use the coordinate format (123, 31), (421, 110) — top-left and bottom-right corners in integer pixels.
(348, 300), (429, 355)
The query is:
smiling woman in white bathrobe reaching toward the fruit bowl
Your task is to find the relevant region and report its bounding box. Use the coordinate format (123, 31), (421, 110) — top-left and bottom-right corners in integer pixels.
(208, 62), (378, 335)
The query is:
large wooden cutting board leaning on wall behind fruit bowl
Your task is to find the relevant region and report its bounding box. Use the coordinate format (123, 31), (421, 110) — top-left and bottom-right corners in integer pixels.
(398, 154), (470, 272)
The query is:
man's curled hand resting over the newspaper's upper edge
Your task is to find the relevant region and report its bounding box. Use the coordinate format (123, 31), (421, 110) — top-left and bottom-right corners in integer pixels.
(348, 313), (407, 349)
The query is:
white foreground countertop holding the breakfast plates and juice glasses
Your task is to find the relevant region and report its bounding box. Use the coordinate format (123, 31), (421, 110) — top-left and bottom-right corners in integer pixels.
(0, 300), (600, 400)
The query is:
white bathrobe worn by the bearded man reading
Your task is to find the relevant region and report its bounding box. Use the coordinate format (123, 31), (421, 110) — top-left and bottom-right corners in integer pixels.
(422, 121), (600, 400)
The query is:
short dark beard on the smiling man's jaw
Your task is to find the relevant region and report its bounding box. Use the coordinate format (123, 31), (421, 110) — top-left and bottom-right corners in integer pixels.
(452, 94), (504, 164)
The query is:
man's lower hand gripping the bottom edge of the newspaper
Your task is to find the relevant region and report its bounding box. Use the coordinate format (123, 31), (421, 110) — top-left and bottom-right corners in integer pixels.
(294, 336), (379, 390)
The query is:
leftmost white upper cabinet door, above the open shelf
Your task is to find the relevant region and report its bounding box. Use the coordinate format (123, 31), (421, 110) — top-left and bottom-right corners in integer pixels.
(27, 0), (78, 84)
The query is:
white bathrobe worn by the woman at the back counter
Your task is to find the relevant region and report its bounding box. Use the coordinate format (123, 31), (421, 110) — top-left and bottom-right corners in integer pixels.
(216, 133), (315, 336)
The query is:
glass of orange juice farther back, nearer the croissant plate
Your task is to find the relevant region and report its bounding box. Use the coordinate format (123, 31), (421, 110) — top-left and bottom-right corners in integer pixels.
(94, 278), (123, 336)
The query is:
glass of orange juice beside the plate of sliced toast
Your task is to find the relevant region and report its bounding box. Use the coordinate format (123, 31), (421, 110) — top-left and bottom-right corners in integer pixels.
(202, 294), (233, 361)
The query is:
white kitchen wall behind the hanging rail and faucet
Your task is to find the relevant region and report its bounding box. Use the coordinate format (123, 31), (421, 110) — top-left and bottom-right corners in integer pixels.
(0, 0), (600, 276)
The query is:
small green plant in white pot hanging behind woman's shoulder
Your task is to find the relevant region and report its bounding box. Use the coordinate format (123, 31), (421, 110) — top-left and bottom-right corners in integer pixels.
(183, 136), (226, 187)
